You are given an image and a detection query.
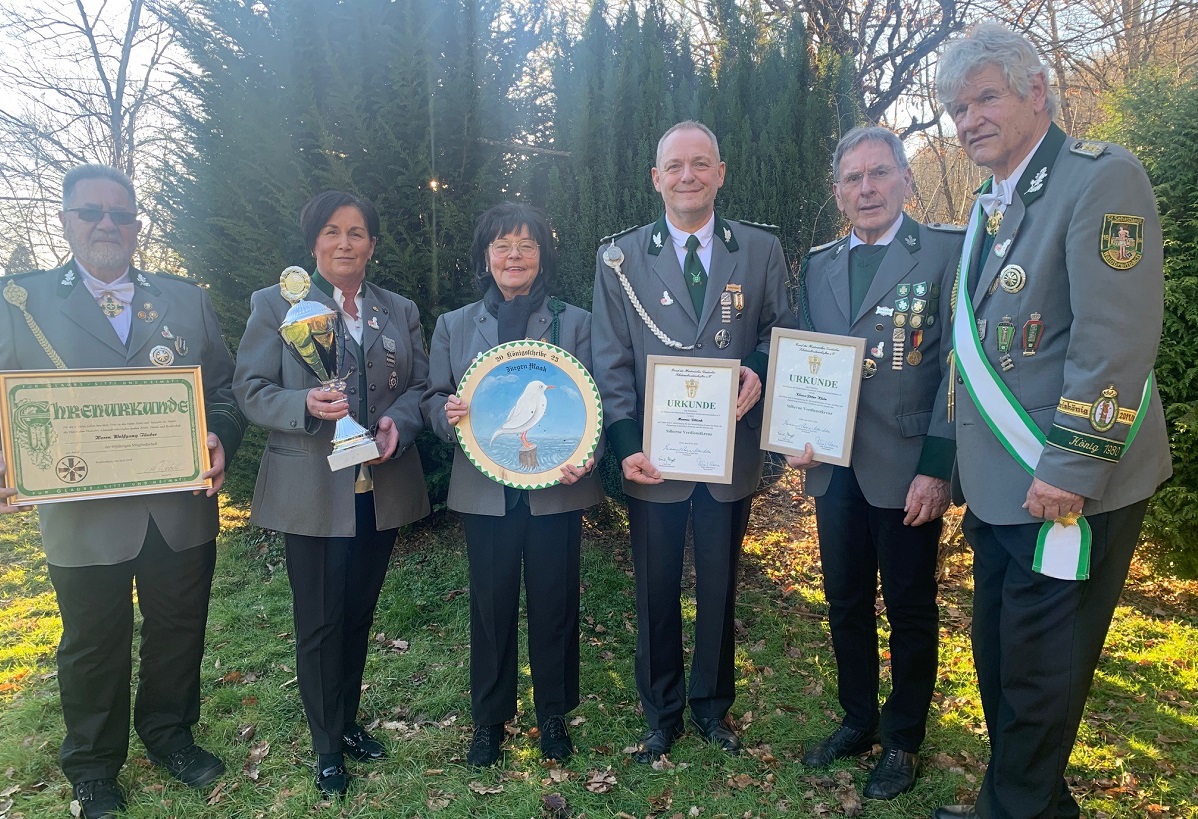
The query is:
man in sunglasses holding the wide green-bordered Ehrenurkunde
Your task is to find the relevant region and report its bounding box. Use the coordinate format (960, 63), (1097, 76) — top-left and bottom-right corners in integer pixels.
(0, 165), (246, 819)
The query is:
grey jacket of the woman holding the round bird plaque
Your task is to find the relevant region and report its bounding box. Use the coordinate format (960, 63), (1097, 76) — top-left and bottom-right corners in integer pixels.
(422, 299), (603, 516)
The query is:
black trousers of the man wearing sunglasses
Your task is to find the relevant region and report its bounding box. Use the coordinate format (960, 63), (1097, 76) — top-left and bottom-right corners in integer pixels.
(49, 520), (217, 784)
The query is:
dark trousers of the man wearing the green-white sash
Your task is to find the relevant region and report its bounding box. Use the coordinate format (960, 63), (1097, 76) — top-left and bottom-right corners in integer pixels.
(963, 501), (1148, 819)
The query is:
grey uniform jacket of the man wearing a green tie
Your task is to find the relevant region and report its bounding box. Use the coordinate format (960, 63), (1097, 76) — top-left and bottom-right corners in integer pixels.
(592, 214), (793, 503)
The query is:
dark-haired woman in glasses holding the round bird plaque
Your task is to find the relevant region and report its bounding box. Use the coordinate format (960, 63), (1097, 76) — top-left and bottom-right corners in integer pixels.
(422, 204), (603, 766)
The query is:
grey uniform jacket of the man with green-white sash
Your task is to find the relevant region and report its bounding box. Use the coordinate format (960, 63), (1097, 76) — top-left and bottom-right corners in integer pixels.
(956, 126), (1172, 524)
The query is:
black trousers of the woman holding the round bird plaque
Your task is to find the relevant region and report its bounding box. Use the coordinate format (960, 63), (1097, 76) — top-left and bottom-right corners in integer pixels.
(462, 499), (582, 726)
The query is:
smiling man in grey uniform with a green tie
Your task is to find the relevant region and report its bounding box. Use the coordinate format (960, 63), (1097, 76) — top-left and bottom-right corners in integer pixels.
(592, 121), (789, 763)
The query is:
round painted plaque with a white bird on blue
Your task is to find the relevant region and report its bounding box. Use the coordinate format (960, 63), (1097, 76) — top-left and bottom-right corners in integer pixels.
(456, 339), (603, 489)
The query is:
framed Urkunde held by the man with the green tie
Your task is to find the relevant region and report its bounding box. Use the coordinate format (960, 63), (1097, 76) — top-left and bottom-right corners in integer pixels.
(645, 356), (740, 484)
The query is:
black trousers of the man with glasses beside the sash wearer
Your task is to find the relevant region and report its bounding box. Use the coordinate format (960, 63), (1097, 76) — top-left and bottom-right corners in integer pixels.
(816, 466), (943, 753)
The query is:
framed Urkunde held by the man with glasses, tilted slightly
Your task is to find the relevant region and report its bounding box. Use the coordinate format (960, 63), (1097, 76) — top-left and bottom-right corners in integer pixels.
(761, 327), (865, 466)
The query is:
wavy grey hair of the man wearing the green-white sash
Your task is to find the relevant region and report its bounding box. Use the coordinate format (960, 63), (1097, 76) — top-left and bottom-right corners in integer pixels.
(936, 23), (1059, 120)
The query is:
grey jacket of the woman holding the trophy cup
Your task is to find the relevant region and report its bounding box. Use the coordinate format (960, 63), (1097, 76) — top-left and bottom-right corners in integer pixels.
(234, 281), (429, 538)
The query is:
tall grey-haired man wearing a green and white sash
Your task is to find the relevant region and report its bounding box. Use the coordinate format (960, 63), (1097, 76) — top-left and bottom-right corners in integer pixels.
(933, 24), (1170, 819)
